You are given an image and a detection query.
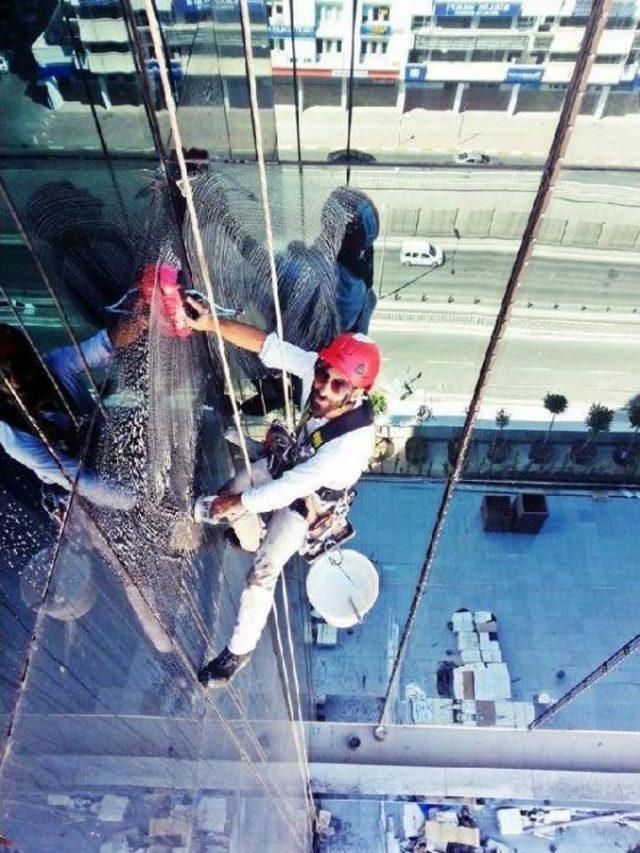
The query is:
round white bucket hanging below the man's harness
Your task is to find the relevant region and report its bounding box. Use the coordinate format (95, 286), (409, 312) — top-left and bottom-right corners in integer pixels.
(307, 550), (379, 628)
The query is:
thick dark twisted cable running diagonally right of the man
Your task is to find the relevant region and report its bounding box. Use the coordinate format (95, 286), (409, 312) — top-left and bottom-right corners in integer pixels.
(376, 0), (613, 737)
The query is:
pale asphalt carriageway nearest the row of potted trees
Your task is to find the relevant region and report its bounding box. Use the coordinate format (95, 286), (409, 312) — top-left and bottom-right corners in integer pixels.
(372, 322), (640, 408)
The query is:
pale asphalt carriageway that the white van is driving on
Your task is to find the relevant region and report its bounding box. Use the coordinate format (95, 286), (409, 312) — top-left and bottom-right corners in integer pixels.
(376, 246), (640, 311)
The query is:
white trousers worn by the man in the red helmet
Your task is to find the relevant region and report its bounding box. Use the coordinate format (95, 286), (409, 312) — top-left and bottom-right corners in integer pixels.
(224, 459), (308, 655)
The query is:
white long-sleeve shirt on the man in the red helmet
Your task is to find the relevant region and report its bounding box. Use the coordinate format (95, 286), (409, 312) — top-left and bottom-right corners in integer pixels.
(241, 332), (375, 513)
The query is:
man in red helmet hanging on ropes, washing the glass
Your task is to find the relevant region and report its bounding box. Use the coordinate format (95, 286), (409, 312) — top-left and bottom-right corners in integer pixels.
(191, 303), (380, 687)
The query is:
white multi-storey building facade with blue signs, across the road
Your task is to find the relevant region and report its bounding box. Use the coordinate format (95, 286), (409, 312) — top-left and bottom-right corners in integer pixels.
(267, 0), (640, 117)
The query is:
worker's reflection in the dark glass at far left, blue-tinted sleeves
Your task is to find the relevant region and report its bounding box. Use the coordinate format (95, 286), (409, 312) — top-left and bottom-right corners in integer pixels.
(0, 313), (147, 509)
